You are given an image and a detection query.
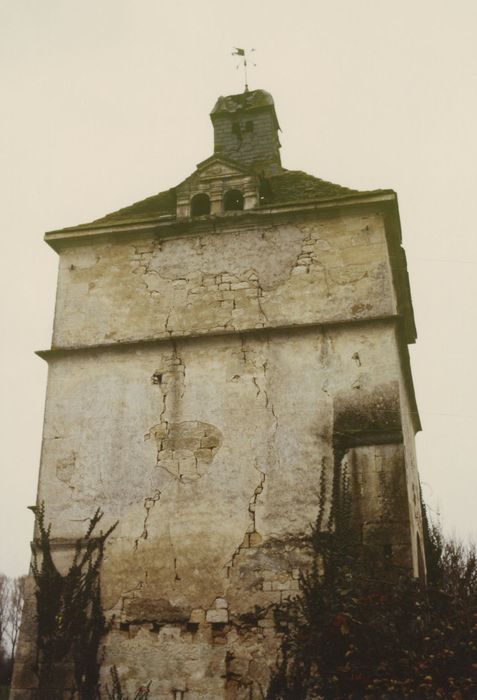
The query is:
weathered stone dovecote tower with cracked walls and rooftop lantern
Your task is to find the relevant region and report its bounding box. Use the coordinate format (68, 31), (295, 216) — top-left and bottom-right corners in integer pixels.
(13, 90), (424, 700)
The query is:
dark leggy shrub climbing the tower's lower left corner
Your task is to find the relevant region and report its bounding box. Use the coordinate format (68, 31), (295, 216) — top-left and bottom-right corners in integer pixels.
(32, 503), (150, 700)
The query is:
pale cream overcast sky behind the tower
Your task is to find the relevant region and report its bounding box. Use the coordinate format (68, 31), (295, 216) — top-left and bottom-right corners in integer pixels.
(0, 0), (477, 576)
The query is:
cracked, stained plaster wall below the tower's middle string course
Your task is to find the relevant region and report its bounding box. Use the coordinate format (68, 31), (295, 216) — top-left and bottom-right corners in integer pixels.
(14, 322), (420, 700)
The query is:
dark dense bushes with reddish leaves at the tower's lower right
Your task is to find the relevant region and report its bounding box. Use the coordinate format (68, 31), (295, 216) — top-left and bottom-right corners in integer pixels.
(266, 469), (477, 700)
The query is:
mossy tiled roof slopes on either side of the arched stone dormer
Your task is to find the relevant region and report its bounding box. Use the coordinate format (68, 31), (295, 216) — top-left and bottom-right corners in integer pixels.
(70, 169), (376, 228)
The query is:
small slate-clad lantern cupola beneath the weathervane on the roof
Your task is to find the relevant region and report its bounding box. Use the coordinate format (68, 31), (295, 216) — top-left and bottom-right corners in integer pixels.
(210, 90), (282, 176)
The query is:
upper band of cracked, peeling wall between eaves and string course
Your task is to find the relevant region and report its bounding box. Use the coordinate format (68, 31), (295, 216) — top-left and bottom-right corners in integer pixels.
(53, 214), (396, 346)
